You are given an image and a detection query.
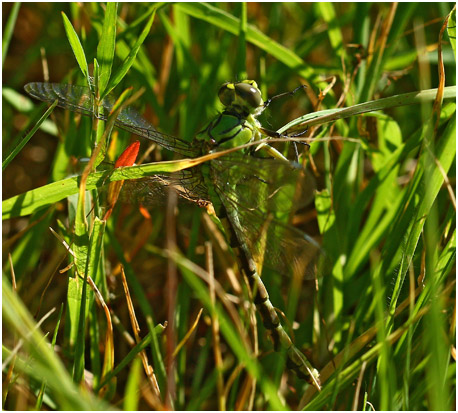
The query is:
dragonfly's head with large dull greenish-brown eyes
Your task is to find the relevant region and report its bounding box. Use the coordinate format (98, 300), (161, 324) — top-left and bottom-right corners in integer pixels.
(218, 80), (264, 117)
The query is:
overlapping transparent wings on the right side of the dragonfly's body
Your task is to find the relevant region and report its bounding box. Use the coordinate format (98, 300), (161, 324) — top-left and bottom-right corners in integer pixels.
(211, 156), (321, 278)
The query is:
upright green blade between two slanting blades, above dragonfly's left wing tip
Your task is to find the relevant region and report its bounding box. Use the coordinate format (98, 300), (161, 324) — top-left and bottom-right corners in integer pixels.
(97, 2), (118, 94)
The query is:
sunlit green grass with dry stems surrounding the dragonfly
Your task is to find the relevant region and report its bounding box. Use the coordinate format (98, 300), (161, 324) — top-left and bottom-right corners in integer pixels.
(2, 3), (456, 410)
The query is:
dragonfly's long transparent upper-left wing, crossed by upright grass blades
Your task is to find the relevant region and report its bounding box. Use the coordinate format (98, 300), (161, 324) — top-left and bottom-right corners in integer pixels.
(24, 82), (199, 157)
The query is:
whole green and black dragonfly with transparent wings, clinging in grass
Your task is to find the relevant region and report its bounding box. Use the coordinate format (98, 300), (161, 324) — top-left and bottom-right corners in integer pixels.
(25, 80), (321, 389)
